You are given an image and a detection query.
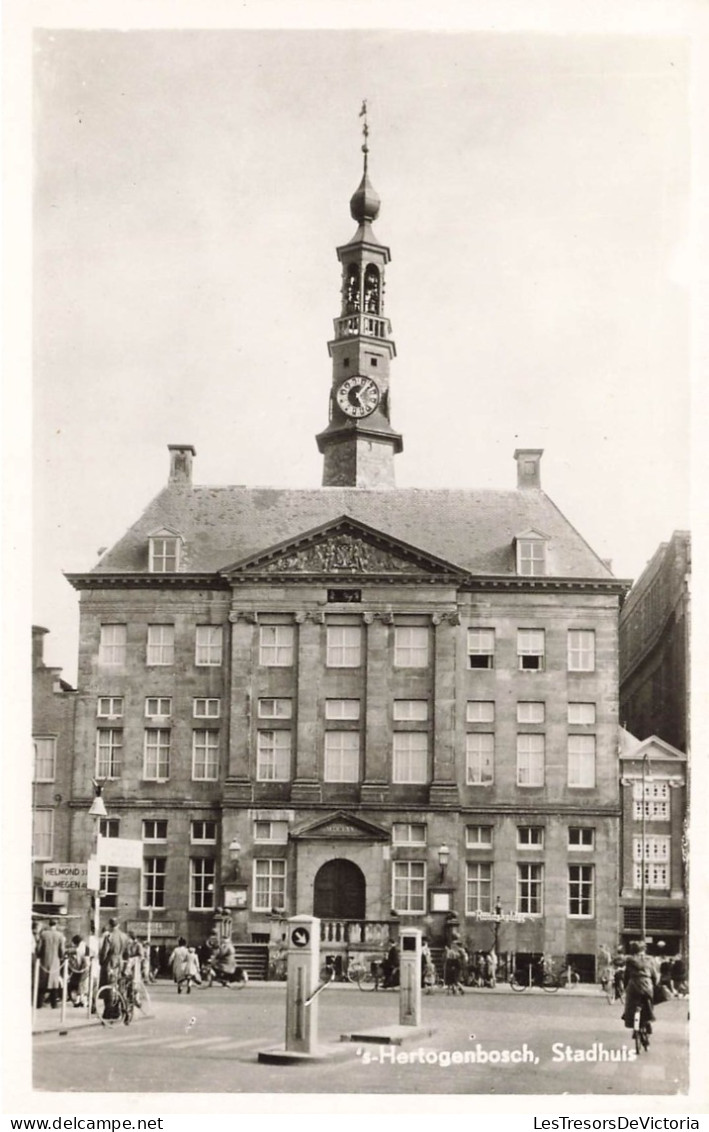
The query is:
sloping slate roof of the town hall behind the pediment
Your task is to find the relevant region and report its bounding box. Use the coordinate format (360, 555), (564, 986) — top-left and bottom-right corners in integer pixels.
(91, 484), (613, 578)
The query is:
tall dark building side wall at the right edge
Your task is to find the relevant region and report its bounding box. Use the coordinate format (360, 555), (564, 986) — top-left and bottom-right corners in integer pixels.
(620, 531), (692, 753)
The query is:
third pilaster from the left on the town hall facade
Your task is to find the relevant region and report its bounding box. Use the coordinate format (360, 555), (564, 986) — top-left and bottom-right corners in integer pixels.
(360, 614), (393, 805)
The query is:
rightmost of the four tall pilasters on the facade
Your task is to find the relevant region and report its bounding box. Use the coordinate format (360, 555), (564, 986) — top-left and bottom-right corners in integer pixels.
(429, 614), (460, 806)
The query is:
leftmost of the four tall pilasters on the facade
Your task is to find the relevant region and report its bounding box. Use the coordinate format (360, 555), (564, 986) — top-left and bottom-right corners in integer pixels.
(225, 610), (257, 801)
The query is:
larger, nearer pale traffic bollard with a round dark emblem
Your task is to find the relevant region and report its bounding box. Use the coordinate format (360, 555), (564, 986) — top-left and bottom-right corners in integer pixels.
(285, 916), (321, 1054)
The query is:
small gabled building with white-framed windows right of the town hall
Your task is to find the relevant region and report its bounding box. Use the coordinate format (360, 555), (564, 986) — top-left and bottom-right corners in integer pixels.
(620, 728), (687, 955)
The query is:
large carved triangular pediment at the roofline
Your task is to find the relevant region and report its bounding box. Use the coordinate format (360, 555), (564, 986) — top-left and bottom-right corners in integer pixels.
(221, 516), (463, 581)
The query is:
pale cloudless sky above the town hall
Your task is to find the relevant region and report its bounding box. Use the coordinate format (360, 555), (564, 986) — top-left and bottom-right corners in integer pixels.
(32, 27), (691, 680)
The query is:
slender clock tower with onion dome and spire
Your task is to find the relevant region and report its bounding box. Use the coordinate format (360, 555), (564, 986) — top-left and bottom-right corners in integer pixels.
(316, 103), (403, 488)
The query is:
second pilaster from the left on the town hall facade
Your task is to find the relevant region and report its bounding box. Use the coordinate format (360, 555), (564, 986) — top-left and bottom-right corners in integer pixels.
(291, 612), (324, 803)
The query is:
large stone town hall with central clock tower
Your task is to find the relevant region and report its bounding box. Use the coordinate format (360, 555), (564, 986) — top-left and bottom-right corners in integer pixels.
(63, 143), (629, 975)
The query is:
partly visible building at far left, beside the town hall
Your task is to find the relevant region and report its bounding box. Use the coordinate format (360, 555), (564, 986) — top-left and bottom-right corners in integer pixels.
(32, 625), (76, 914)
